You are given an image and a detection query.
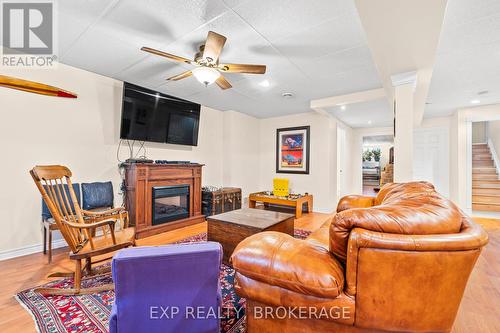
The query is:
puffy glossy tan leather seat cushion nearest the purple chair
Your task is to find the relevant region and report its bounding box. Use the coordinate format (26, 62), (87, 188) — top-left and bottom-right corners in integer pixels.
(231, 231), (344, 298)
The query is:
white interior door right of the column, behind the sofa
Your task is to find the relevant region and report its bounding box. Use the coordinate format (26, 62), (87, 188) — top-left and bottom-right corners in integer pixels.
(413, 128), (450, 197)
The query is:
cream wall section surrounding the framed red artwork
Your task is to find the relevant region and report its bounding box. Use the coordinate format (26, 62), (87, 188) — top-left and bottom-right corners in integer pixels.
(260, 112), (336, 212)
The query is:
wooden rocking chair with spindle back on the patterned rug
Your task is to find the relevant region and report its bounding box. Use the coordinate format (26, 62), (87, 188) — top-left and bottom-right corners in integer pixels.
(30, 165), (135, 295)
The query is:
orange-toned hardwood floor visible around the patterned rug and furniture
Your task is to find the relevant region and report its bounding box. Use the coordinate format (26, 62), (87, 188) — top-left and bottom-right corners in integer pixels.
(0, 213), (500, 333)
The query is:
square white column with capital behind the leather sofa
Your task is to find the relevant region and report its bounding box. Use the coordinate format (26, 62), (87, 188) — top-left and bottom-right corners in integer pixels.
(391, 72), (417, 182)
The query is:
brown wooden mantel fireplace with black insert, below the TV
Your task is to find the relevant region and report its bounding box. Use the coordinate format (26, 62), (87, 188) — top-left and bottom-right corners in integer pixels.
(124, 163), (205, 239)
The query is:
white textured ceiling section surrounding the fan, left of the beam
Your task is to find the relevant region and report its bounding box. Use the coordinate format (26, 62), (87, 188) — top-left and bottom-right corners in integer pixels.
(58, 0), (381, 118)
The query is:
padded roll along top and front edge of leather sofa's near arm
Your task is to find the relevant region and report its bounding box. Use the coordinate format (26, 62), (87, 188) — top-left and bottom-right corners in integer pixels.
(344, 219), (488, 296)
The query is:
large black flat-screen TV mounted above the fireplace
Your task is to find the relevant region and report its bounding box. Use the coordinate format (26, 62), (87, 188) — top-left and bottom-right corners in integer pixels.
(120, 82), (201, 146)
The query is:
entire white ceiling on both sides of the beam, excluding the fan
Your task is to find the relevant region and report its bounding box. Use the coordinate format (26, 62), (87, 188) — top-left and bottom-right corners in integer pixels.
(53, 0), (500, 122)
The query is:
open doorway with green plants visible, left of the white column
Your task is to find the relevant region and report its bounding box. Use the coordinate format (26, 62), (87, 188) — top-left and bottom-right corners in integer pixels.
(362, 135), (394, 196)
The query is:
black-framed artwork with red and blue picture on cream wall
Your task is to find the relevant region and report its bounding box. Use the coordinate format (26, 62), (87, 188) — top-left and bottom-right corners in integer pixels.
(276, 126), (310, 174)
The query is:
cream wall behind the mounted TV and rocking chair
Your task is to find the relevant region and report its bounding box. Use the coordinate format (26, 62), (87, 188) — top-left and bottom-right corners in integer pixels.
(0, 64), (236, 258)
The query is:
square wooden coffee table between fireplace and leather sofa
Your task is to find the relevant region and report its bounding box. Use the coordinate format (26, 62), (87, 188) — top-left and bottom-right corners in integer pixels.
(207, 208), (294, 265)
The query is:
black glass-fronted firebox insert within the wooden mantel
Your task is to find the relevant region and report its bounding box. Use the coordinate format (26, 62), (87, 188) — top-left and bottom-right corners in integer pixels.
(152, 185), (189, 225)
